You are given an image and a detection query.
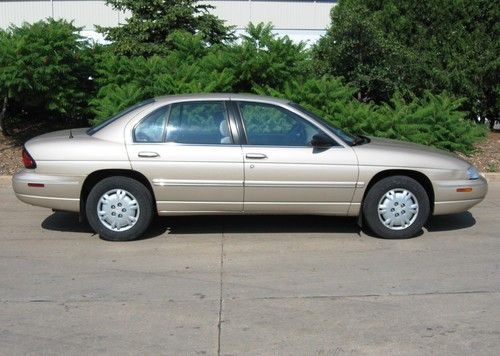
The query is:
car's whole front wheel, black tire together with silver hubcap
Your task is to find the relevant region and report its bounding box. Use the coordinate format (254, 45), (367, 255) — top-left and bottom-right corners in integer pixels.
(363, 176), (430, 239)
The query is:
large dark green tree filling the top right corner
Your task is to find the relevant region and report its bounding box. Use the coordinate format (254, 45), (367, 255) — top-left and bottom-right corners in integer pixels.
(314, 0), (500, 126)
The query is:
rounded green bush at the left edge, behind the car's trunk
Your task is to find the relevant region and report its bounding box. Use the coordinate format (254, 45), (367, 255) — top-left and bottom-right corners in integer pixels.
(0, 19), (93, 126)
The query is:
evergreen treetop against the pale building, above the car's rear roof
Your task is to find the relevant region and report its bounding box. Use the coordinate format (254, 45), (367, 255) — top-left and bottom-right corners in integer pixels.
(97, 0), (233, 57)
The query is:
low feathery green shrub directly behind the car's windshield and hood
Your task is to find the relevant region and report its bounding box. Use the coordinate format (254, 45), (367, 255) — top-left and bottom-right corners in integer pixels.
(258, 76), (485, 153)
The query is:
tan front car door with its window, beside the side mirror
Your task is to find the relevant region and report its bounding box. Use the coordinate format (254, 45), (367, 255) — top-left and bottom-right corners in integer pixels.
(235, 101), (358, 215)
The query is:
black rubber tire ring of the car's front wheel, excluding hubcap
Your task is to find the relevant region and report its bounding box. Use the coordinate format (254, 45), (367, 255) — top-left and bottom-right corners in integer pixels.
(363, 176), (430, 239)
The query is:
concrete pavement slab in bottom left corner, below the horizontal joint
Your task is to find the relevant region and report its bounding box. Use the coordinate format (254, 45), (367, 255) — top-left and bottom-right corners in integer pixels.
(0, 300), (219, 355)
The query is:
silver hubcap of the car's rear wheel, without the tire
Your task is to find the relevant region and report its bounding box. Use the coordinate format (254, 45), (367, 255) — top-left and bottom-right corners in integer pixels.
(97, 189), (141, 232)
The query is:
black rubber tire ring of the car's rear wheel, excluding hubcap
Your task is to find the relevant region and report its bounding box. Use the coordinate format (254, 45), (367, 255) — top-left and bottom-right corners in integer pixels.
(85, 176), (154, 241)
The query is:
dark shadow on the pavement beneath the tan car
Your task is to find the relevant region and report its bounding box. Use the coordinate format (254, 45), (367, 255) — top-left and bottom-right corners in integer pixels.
(42, 212), (476, 240)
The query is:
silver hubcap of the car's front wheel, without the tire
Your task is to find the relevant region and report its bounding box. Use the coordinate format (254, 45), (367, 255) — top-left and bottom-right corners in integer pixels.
(378, 188), (418, 230)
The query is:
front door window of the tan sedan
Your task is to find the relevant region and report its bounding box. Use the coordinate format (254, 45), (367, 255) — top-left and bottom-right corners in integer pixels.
(239, 102), (321, 146)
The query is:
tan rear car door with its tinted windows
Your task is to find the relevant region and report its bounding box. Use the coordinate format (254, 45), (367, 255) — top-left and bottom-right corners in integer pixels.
(127, 100), (243, 215)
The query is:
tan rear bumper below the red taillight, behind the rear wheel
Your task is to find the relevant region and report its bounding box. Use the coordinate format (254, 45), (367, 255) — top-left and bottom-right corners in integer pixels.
(12, 169), (83, 212)
